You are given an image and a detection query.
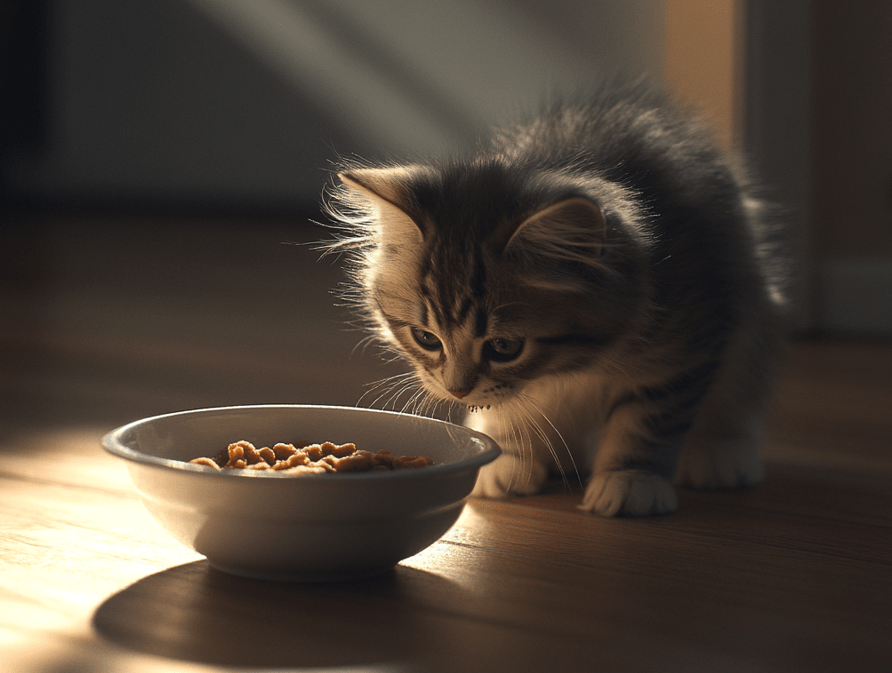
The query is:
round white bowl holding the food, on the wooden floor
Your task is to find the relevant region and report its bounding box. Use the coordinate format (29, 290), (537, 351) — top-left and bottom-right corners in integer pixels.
(102, 405), (499, 581)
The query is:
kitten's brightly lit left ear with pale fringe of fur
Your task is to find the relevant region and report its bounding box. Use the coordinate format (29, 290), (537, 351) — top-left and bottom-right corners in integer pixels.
(338, 167), (423, 243)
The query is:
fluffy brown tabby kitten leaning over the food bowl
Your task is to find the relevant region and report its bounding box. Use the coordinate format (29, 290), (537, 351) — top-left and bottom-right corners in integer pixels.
(327, 84), (783, 516)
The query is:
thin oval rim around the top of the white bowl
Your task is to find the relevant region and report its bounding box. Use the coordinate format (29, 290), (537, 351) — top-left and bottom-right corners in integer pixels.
(100, 404), (501, 483)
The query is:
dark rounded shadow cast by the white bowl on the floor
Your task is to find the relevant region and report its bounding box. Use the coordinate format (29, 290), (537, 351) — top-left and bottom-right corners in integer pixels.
(93, 561), (457, 667)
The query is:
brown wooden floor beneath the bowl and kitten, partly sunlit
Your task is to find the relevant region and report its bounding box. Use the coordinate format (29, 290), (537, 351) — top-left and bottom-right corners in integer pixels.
(0, 215), (892, 673)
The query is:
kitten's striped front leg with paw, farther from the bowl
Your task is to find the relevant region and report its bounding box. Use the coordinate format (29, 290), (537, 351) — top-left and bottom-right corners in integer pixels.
(580, 395), (693, 516)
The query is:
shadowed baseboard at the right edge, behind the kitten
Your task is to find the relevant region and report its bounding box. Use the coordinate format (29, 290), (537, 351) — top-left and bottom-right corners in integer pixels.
(815, 258), (892, 336)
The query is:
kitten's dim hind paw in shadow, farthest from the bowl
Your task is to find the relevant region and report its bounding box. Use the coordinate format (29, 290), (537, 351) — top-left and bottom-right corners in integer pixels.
(676, 441), (763, 489)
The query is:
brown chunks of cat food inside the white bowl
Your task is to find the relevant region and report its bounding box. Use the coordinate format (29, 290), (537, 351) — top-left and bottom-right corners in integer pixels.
(189, 440), (433, 474)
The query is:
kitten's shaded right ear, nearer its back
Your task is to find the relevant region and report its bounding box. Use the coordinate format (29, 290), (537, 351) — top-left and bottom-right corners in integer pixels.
(505, 197), (607, 266)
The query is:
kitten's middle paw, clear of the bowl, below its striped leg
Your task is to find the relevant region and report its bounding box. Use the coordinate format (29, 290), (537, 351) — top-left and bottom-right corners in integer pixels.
(579, 470), (678, 516)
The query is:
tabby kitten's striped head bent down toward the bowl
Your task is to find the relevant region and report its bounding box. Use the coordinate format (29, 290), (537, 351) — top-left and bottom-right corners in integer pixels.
(331, 161), (646, 408)
